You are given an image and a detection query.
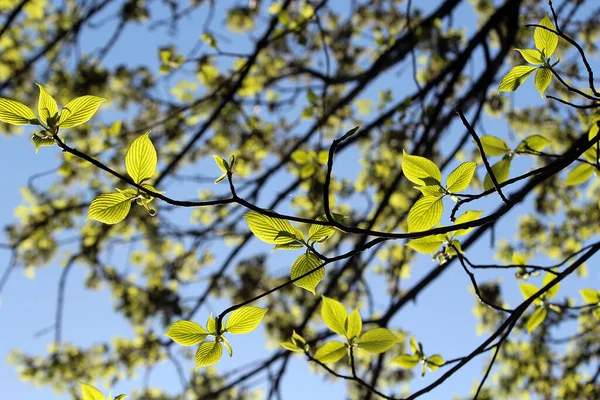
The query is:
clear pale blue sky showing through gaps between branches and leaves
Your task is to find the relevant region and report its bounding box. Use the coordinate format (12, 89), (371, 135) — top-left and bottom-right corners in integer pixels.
(0, 1), (598, 400)
